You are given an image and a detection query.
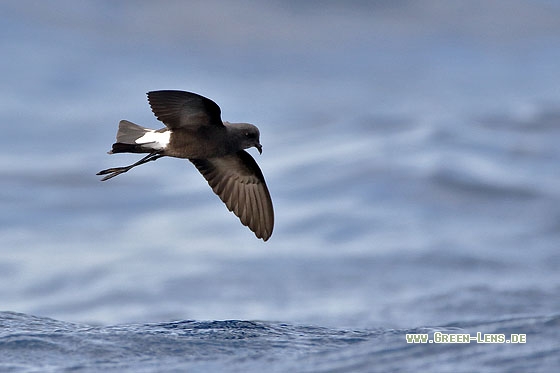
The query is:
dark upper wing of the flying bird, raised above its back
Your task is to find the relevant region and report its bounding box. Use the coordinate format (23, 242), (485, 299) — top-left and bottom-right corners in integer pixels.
(148, 91), (223, 129)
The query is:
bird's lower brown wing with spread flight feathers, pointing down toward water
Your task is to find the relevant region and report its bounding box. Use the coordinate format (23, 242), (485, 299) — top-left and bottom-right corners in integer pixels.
(189, 150), (274, 241)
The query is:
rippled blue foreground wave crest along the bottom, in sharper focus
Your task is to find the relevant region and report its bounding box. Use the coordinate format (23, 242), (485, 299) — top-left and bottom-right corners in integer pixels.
(0, 312), (560, 372)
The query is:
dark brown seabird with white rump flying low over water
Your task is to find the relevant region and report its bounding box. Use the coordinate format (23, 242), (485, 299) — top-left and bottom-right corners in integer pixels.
(97, 90), (274, 241)
